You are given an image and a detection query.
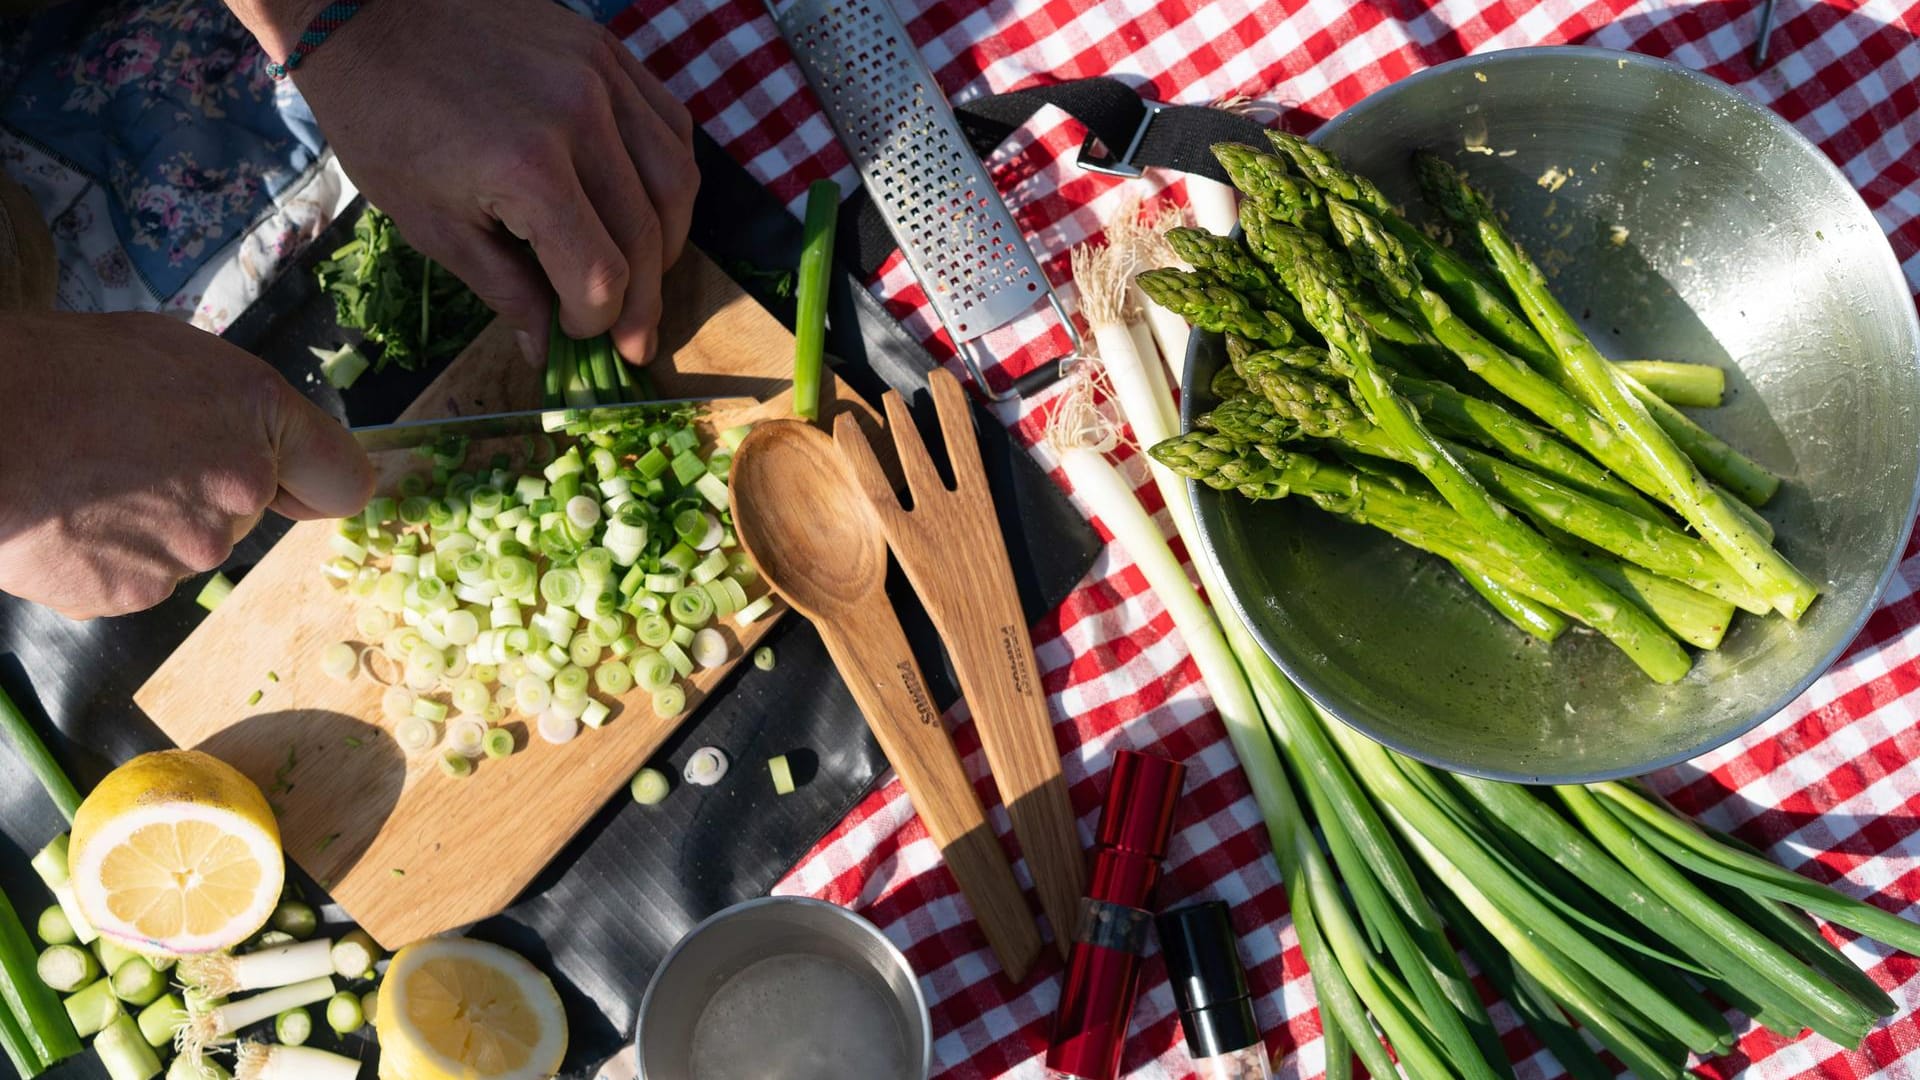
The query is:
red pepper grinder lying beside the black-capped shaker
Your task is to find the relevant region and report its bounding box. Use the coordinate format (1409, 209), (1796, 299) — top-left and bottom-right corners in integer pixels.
(1046, 749), (1187, 1080)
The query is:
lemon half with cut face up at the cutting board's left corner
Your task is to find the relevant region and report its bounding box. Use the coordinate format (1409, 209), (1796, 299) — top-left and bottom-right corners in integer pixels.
(69, 749), (286, 955)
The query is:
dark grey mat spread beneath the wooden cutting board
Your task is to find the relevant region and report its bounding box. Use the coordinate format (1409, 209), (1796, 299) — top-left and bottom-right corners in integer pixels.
(0, 127), (1098, 1080)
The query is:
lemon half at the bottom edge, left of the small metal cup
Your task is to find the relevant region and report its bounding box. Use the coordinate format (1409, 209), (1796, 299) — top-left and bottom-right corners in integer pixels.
(374, 938), (566, 1080)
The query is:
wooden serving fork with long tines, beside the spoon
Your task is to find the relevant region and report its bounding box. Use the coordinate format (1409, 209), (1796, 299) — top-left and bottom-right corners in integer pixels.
(833, 371), (1087, 957)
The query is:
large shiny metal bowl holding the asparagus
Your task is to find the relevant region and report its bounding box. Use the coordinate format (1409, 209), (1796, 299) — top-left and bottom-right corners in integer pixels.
(1185, 48), (1920, 782)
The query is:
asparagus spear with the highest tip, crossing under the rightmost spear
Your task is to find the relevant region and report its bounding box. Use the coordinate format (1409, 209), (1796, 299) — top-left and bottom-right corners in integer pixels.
(1267, 131), (1780, 505)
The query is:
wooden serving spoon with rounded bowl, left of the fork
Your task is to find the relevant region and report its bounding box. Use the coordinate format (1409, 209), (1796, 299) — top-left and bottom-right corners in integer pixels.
(732, 421), (1041, 982)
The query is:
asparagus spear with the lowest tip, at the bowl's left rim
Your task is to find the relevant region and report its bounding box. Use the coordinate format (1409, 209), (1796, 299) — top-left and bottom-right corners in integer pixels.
(1150, 432), (1734, 648)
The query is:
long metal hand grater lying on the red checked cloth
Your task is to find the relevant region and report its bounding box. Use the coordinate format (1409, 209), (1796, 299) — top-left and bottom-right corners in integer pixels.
(768, 0), (1081, 402)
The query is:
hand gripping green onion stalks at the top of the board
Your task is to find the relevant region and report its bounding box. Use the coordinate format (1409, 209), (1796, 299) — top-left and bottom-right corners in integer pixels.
(263, 0), (699, 363)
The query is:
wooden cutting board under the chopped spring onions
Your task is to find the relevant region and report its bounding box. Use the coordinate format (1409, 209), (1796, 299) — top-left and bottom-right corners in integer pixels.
(134, 250), (883, 949)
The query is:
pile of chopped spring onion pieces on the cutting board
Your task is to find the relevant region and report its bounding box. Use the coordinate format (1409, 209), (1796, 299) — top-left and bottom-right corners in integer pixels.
(323, 399), (774, 776)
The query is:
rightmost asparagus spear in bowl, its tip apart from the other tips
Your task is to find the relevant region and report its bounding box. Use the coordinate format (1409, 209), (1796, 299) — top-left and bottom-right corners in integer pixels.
(1419, 154), (1818, 619)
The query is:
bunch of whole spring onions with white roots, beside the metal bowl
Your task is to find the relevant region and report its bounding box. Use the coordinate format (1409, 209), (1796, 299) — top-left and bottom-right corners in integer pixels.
(1050, 222), (1920, 1080)
